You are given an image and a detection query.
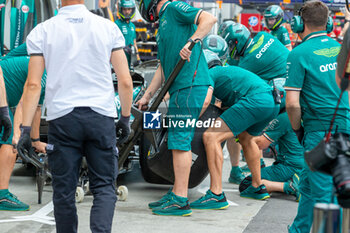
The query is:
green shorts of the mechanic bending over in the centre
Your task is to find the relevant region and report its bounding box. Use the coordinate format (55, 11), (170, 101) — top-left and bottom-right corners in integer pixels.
(220, 91), (279, 136)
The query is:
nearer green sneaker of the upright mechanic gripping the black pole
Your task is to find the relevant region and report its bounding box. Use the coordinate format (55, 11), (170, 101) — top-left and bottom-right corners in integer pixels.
(152, 192), (192, 216)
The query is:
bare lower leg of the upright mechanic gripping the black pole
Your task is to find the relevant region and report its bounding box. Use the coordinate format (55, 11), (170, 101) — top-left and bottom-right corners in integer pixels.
(172, 150), (192, 197)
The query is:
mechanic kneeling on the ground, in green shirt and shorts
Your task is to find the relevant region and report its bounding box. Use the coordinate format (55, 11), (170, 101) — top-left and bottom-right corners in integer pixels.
(255, 112), (304, 201)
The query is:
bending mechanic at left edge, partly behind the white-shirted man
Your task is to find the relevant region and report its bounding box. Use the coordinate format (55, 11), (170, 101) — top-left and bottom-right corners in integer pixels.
(0, 56), (46, 211)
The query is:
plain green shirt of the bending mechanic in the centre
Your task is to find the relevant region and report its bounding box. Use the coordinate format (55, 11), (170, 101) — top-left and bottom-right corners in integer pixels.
(209, 66), (272, 107)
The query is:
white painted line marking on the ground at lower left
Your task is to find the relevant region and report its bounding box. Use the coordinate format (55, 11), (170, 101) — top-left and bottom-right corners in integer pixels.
(0, 201), (56, 225)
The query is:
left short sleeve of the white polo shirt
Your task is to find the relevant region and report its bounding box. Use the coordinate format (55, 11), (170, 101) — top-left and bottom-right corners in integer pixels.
(26, 23), (45, 56)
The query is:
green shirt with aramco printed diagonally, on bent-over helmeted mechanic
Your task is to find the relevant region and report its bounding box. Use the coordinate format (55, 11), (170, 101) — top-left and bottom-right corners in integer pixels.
(238, 32), (289, 82)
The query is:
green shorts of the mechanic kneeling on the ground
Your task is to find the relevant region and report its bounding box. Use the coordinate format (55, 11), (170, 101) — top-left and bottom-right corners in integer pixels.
(261, 163), (301, 182)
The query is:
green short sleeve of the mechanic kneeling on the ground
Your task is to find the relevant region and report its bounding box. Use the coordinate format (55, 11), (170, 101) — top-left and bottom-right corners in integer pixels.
(263, 113), (289, 143)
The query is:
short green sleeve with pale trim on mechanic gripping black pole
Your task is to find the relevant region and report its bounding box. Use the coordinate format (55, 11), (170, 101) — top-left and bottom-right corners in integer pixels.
(171, 2), (202, 24)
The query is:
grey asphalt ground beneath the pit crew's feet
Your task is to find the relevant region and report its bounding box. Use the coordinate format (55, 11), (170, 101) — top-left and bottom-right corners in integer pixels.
(0, 151), (297, 233)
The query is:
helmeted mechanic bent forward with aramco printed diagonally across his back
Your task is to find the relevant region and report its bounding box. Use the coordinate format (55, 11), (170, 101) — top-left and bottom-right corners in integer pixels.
(222, 23), (289, 184)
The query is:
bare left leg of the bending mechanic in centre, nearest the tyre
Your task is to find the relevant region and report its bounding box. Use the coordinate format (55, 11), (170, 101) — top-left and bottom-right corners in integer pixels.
(203, 118), (234, 194)
